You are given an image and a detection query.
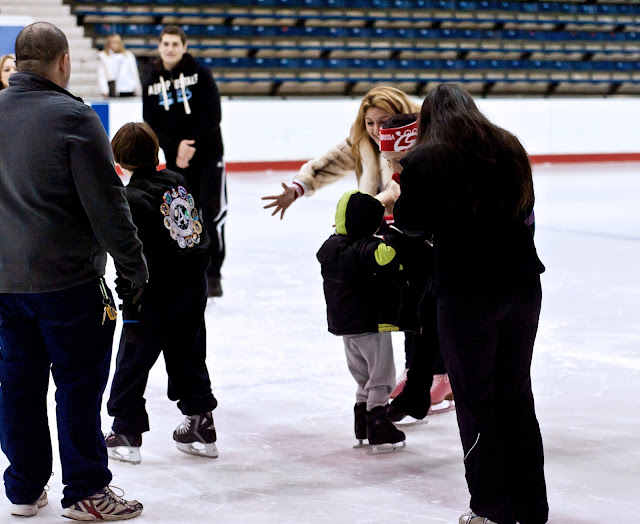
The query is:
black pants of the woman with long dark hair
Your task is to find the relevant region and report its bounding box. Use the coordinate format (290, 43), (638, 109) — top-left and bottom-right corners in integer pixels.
(437, 277), (549, 524)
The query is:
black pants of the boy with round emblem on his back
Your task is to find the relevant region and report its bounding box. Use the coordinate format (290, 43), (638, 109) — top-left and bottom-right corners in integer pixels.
(107, 270), (218, 435)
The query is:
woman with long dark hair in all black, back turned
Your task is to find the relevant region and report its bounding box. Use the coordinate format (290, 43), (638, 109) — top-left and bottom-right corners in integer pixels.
(394, 84), (549, 524)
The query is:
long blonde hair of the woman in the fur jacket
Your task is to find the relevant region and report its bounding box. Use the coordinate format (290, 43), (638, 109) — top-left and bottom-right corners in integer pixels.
(351, 86), (420, 176)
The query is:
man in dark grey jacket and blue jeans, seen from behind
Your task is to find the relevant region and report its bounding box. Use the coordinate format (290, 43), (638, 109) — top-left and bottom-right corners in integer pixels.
(0, 22), (148, 520)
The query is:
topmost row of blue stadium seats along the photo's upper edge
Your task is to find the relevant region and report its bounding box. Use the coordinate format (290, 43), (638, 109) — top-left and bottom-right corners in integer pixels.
(76, 0), (640, 16)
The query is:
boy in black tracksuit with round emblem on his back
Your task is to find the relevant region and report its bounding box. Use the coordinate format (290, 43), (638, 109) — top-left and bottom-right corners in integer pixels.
(107, 123), (218, 463)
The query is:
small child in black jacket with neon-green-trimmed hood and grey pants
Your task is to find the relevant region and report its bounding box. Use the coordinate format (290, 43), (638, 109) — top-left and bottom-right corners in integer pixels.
(317, 190), (405, 452)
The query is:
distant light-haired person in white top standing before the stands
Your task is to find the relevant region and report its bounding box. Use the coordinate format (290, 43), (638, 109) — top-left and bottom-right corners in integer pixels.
(98, 34), (142, 98)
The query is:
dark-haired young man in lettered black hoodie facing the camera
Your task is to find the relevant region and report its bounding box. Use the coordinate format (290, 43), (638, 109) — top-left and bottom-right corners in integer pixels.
(142, 26), (227, 297)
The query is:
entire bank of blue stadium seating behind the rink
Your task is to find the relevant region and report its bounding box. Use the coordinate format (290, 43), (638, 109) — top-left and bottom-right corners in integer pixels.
(74, 0), (640, 96)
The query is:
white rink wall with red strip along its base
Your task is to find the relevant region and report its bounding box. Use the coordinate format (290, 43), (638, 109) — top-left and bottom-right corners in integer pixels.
(91, 98), (640, 171)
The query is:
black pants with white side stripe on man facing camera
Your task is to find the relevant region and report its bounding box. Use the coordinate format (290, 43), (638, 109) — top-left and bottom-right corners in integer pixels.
(175, 157), (227, 280)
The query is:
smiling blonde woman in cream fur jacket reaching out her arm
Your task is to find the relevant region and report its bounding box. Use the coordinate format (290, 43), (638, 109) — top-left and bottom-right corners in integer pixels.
(262, 86), (420, 220)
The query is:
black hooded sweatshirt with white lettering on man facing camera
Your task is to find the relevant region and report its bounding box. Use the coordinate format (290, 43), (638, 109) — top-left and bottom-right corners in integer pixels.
(142, 53), (224, 179)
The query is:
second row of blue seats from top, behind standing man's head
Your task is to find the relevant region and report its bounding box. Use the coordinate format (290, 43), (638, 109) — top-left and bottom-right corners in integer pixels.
(95, 23), (640, 42)
